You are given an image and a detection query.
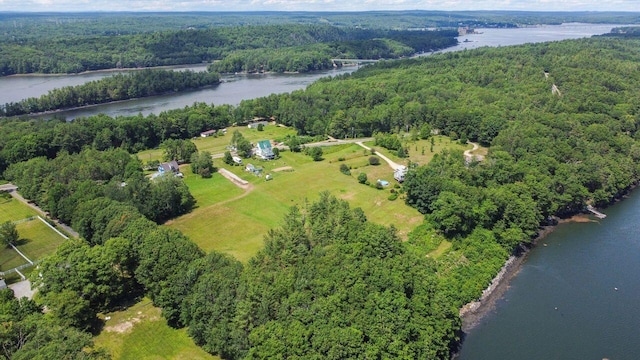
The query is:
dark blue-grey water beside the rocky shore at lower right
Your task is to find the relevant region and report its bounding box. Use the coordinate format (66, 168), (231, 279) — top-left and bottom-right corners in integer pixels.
(457, 191), (640, 360)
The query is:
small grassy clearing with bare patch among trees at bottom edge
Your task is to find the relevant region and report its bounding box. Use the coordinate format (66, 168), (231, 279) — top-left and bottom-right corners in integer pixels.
(94, 298), (220, 360)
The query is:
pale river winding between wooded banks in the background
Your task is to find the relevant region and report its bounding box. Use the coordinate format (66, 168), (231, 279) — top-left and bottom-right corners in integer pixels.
(0, 23), (617, 120)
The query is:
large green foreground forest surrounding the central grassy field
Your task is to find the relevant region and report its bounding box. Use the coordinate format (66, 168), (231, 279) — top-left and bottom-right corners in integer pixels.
(0, 32), (640, 359)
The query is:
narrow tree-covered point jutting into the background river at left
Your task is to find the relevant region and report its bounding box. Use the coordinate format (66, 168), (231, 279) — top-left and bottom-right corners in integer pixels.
(0, 69), (220, 116)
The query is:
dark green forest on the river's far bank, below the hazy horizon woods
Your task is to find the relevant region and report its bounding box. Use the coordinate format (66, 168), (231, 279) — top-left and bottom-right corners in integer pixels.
(0, 24), (457, 76)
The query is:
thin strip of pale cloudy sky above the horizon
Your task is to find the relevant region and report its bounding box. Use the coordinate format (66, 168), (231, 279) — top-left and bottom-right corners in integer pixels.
(0, 0), (640, 12)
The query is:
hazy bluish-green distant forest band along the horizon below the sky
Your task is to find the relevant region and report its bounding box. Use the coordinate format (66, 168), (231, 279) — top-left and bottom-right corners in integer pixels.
(0, 10), (638, 42)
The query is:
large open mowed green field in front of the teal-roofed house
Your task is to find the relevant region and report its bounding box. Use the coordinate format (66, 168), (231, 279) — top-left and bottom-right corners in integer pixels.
(167, 144), (423, 261)
